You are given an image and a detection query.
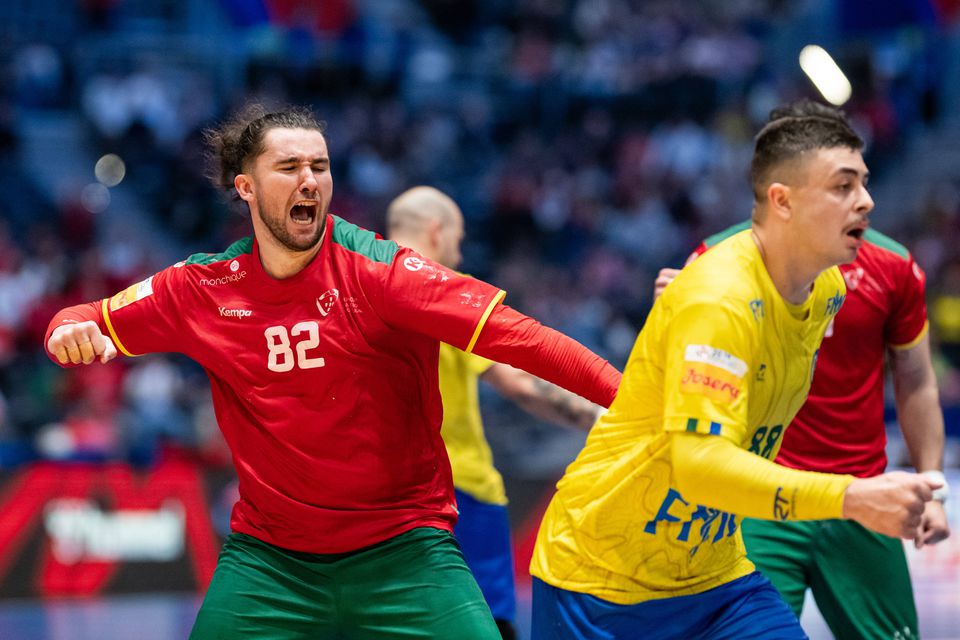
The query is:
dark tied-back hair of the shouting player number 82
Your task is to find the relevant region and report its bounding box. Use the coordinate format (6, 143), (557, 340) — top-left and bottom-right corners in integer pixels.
(203, 104), (326, 192)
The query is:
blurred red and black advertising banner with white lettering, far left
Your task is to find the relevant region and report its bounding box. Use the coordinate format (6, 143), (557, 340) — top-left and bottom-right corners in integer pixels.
(0, 460), (233, 598)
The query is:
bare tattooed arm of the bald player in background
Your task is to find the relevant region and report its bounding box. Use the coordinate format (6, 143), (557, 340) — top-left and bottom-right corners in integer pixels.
(480, 362), (602, 429)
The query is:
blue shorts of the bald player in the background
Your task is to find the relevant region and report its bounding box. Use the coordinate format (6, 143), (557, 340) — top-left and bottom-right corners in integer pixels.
(453, 489), (517, 622)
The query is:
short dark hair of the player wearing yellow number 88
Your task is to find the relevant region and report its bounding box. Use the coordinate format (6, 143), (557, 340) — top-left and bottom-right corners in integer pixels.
(750, 99), (863, 203)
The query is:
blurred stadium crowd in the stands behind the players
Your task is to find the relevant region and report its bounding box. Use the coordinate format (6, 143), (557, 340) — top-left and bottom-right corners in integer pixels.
(0, 0), (960, 467)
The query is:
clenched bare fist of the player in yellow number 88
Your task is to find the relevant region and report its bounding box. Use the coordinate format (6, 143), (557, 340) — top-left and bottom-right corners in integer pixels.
(843, 471), (941, 539)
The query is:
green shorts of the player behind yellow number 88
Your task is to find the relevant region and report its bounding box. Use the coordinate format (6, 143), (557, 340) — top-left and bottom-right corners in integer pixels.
(743, 519), (920, 640)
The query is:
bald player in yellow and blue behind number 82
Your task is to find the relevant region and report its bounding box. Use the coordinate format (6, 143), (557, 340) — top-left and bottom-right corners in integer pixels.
(387, 186), (599, 640)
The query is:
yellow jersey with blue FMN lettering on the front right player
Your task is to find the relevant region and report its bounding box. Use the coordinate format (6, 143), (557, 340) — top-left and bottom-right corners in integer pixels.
(531, 230), (846, 604)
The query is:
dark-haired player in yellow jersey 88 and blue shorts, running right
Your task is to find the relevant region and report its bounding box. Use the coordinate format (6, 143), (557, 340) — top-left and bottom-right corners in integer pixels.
(531, 97), (936, 640)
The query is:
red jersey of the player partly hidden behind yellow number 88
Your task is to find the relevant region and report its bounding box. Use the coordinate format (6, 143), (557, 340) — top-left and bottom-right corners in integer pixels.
(695, 222), (927, 477)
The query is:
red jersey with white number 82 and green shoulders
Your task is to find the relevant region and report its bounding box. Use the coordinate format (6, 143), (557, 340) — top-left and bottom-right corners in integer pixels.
(47, 216), (619, 553)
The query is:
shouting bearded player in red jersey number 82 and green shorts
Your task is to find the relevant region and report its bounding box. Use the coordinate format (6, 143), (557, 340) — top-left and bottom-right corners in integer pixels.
(46, 108), (620, 640)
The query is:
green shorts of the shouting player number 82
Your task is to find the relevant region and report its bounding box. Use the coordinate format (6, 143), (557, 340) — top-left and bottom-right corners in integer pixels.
(190, 528), (500, 640)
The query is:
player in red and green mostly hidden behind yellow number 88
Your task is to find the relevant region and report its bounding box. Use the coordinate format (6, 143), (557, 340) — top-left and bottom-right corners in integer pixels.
(655, 129), (950, 639)
